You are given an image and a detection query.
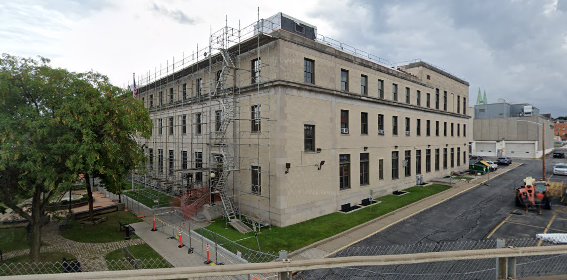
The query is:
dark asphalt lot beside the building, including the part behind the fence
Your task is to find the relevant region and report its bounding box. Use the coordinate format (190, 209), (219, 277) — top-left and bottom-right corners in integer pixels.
(298, 154), (567, 280)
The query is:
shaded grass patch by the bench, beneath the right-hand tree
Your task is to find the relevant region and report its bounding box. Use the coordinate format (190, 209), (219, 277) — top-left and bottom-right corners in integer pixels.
(61, 211), (142, 243)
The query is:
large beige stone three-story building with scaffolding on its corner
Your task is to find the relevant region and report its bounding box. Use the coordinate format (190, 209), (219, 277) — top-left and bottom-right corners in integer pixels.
(134, 13), (472, 226)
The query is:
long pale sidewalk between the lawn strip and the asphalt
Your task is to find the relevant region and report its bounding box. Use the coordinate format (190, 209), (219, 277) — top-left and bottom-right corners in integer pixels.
(290, 163), (522, 260)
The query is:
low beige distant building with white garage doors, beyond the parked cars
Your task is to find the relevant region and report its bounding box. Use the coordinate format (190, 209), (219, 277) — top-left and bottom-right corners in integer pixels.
(471, 102), (554, 158)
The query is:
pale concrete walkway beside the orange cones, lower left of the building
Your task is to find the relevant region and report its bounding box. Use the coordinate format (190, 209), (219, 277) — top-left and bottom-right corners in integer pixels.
(131, 222), (209, 267)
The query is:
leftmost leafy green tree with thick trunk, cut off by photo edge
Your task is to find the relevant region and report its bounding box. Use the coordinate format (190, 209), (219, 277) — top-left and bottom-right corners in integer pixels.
(0, 54), (75, 261)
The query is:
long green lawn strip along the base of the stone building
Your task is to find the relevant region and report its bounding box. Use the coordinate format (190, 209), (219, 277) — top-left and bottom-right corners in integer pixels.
(197, 185), (450, 252)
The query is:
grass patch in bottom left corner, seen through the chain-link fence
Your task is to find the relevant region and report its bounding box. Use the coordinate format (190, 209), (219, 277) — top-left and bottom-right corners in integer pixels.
(0, 252), (76, 276)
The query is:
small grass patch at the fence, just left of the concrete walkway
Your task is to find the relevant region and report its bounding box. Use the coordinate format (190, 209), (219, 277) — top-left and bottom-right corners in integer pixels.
(104, 244), (173, 270)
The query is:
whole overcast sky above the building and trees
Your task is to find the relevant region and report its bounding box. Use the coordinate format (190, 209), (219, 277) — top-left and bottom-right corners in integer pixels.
(0, 0), (567, 116)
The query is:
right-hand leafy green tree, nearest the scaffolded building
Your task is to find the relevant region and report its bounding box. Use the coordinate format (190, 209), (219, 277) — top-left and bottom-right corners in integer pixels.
(61, 73), (152, 218)
